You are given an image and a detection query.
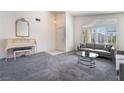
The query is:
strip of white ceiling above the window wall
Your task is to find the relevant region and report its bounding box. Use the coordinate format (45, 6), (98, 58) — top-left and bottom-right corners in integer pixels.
(68, 11), (124, 16)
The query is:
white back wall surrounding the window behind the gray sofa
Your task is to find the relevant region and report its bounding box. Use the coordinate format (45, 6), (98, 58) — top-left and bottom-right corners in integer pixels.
(74, 14), (124, 49)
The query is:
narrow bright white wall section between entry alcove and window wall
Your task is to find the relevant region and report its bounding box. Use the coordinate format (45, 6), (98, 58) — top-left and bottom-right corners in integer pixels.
(66, 13), (74, 52)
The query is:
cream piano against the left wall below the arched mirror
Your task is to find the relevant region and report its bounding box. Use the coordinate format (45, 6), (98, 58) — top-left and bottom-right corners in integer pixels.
(5, 38), (37, 61)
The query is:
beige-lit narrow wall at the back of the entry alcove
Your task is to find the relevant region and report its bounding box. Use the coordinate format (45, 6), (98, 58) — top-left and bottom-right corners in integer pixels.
(55, 12), (66, 52)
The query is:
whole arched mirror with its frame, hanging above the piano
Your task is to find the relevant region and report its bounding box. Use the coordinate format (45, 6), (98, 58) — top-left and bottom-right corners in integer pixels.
(16, 18), (30, 37)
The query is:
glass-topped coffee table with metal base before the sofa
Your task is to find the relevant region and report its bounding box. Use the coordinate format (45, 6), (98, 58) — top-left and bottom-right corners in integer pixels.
(76, 51), (99, 68)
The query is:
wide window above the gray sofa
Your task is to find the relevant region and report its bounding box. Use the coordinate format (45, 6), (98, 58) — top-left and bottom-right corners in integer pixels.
(83, 25), (116, 45)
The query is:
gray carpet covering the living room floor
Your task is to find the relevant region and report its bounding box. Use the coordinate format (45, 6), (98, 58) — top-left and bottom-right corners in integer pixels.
(0, 52), (117, 81)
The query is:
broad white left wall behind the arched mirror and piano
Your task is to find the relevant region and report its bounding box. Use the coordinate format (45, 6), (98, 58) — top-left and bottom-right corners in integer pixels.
(0, 12), (56, 58)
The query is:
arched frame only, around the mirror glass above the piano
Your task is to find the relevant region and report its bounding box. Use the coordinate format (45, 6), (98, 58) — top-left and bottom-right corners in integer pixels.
(15, 18), (30, 37)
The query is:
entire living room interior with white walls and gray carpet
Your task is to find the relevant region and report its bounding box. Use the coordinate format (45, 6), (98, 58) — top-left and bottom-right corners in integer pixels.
(0, 11), (124, 81)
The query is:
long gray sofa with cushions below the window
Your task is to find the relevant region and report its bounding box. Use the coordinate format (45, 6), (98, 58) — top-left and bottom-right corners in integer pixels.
(77, 43), (115, 62)
